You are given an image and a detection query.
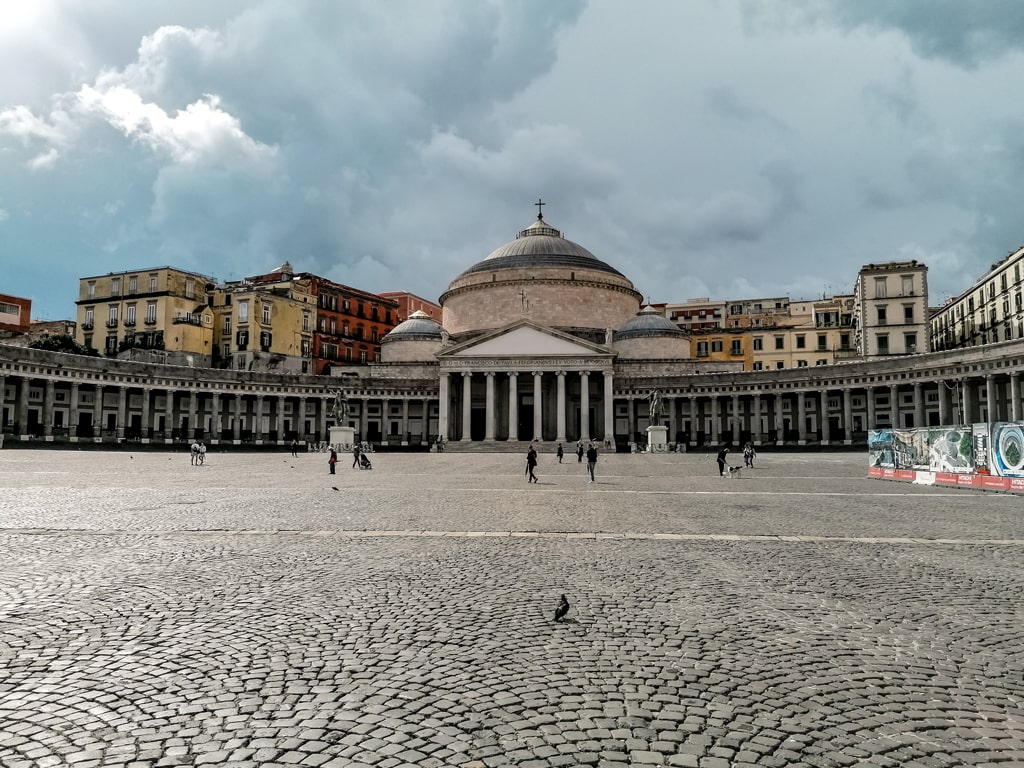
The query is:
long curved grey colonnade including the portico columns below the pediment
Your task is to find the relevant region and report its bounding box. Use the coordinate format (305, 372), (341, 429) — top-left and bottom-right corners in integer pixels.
(0, 341), (1024, 447)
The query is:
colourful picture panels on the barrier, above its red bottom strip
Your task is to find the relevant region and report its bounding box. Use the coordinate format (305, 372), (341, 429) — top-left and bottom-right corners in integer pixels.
(867, 422), (1024, 477)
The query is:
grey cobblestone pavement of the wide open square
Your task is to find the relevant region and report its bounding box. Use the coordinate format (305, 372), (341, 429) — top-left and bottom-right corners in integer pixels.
(0, 449), (1024, 768)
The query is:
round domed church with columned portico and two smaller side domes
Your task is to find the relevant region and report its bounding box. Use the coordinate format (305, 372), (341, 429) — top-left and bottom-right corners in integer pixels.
(364, 204), (741, 447)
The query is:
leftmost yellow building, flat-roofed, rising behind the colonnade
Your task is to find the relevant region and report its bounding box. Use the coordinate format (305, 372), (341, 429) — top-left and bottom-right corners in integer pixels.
(76, 266), (216, 367)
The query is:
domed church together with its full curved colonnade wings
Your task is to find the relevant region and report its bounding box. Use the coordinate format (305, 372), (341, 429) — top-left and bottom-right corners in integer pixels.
(0, 210), (1024, 451)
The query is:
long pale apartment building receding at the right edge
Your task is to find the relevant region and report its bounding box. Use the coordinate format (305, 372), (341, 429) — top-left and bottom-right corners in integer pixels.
(930, 247), (1024, 351)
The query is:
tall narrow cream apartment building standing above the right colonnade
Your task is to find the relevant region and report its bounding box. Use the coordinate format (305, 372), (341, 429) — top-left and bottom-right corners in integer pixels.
(853, 260), (931, 357)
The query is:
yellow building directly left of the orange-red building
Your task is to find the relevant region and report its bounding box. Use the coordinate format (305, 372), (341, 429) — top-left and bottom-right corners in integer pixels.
(211, 261), (316, 374)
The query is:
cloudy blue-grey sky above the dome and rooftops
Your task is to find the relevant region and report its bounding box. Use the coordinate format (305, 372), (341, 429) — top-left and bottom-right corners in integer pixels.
(0, 0), (1024, 319)
